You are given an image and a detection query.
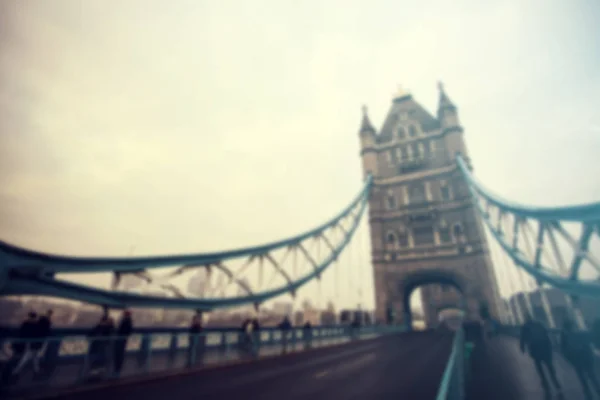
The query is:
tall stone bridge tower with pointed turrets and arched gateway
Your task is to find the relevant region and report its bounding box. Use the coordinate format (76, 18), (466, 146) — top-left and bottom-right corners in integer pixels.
(359, 84), (500, 326)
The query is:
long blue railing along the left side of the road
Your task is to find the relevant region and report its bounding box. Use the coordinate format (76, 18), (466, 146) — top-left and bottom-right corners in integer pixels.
(0, 326), (404, 396)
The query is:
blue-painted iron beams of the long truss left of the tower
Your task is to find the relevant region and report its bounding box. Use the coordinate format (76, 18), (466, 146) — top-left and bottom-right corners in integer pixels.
(0, 176), (372, 310)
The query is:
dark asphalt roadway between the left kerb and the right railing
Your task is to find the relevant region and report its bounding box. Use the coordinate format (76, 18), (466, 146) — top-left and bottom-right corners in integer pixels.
(32, 333), (452, 400)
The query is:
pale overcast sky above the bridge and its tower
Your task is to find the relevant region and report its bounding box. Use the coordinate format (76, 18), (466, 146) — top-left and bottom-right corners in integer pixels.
(0, 0), (600, 312)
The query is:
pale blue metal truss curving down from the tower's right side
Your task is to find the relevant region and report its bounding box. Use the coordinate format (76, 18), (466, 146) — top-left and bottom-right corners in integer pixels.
(457, 156), (600, 297)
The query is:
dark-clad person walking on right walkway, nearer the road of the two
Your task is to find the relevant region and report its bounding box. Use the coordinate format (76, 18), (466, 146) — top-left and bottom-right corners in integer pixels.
(520, 316), (561, 391)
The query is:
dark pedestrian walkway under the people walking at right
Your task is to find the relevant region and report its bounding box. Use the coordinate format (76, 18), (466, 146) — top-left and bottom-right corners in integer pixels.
(467, 337), (586, 400)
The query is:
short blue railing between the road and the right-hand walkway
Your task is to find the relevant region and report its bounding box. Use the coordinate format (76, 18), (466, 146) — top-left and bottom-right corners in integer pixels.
(436, 328), (465, 400)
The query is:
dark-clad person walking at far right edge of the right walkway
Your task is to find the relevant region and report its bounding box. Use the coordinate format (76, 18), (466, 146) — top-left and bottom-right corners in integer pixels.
(560, 320), (600, 396)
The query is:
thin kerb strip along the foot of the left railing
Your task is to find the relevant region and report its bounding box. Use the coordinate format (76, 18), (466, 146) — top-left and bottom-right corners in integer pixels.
(19, 334), (393, 400)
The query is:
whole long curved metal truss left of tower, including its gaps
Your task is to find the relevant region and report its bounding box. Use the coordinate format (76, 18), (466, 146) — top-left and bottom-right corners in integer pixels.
(0, 177), (372, 310)
